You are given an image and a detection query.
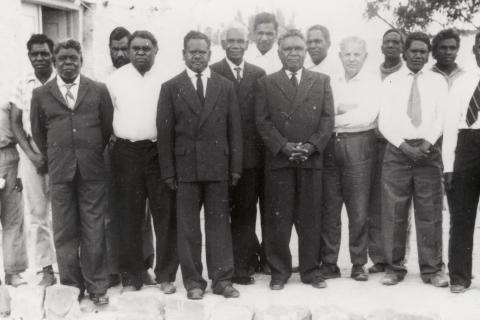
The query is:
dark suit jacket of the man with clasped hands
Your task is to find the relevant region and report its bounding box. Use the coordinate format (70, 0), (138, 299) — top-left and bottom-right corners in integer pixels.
(255, 69), (334, 169)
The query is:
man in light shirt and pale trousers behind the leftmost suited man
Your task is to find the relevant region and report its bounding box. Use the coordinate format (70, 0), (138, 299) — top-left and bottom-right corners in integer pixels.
(10, 34), (57, 286)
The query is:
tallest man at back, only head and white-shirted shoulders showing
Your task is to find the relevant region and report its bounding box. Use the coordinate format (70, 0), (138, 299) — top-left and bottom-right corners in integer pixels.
(245, 12), (282, 74)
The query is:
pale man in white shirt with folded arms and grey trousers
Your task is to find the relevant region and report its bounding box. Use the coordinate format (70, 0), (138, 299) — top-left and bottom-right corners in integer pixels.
(320, 37), (380, 281)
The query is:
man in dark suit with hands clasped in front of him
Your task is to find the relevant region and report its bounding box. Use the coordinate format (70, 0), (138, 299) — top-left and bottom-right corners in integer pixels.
(255, 30), (333, 290)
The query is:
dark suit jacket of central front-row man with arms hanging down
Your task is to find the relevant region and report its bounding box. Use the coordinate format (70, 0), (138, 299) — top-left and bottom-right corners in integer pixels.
(157, 71), (242, 182)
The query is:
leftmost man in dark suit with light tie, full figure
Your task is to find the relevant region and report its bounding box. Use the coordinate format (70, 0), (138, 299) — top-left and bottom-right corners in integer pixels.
(30, 40), (112, 304)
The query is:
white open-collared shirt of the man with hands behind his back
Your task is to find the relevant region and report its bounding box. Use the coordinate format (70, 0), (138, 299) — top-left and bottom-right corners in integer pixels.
(106, 63), (163, 142)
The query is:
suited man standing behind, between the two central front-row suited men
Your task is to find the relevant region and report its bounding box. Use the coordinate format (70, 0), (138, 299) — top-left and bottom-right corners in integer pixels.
(210, 24), (265, 284)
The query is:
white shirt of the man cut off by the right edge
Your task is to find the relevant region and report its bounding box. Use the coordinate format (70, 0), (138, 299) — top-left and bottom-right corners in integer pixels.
(442, 72), (480, 172)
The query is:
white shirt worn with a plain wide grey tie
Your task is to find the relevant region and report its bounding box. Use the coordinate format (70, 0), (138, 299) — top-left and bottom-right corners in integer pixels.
(379, 66), (448, 148)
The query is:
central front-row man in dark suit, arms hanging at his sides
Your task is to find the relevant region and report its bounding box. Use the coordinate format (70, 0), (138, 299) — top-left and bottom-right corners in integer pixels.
(157, 31), (242, 299)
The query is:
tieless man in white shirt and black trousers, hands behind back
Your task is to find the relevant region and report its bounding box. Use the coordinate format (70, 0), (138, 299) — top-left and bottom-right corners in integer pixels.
(107, 31), (178, 294)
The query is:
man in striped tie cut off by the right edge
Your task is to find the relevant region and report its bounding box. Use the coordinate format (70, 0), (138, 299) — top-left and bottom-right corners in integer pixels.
(442, 33), (480, 293)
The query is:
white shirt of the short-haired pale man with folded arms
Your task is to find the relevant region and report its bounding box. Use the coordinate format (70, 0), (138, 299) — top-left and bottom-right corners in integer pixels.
(332, 69), (381, 132)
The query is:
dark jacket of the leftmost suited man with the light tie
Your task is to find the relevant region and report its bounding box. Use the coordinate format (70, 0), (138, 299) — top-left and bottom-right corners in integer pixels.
(30, 76), (113, 183)
